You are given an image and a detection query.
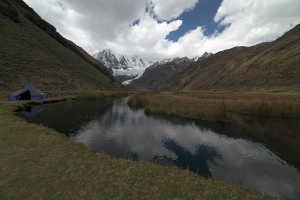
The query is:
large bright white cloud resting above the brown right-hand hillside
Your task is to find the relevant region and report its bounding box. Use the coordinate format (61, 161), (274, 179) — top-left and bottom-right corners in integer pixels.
(161, 0), (300, 57)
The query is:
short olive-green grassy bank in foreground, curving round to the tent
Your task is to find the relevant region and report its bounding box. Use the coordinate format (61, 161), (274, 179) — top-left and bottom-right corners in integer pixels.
(0, 98), (278, 199)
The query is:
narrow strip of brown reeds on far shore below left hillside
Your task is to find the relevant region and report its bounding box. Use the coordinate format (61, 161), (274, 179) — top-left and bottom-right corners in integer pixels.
(75, 92), (128, 100)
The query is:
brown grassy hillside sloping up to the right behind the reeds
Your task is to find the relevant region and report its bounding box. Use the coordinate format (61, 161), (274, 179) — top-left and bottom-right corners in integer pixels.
(156, 25), (300, 92)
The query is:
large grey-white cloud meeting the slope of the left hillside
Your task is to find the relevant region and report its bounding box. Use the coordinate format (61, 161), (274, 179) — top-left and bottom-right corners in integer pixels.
(25, 0), (147, 53)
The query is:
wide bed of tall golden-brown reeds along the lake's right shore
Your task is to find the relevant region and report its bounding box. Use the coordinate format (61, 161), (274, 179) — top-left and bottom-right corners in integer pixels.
(128, 92), (300, 122)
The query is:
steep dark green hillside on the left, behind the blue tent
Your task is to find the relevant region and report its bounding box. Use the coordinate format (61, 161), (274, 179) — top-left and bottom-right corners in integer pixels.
(0, 0), (123, 93)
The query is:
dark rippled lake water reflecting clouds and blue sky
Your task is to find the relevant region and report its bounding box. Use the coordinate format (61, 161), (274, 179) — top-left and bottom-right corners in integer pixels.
(18, 97), (300, 199)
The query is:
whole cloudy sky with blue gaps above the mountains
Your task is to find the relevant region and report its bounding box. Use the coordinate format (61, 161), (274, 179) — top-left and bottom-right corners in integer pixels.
(24, 0), (300, 60)
